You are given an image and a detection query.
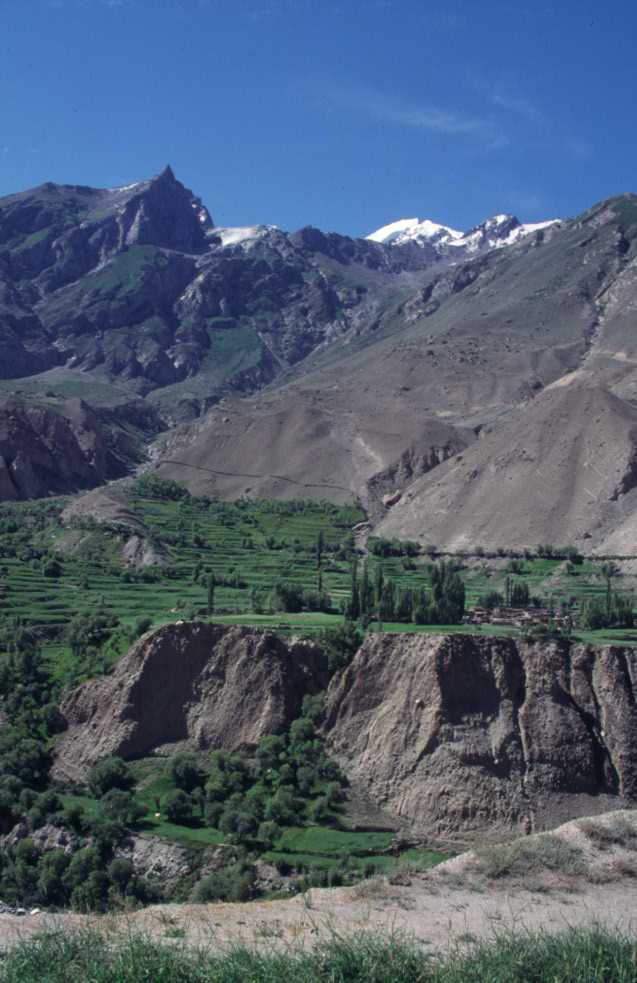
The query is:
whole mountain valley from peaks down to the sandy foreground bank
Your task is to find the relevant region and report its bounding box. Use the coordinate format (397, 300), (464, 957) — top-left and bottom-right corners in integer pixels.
(0, 168), (637, 932)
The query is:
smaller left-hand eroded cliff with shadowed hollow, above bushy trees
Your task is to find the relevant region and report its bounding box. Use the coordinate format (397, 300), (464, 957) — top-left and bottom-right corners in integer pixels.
(54, 622), (327, 781)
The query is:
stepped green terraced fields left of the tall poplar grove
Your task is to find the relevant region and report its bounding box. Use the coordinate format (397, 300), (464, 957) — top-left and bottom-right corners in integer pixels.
(0, 495), (361, 676)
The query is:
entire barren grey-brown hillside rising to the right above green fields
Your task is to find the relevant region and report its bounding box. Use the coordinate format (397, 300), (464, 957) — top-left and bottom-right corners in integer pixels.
(149, 196), (637, 552)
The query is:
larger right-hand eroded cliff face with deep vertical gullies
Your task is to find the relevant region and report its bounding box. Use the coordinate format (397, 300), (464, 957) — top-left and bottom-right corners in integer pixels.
(326, 635), (637, 835)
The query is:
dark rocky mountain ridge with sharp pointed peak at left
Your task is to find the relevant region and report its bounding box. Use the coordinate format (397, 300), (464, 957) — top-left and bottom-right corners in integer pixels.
(0, 167), (568, 414)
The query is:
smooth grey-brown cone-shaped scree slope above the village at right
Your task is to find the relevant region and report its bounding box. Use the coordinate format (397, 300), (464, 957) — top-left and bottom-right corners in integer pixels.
(378, 383), (637, 553)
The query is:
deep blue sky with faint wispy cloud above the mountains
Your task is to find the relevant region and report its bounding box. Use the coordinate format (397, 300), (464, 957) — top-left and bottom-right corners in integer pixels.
(0, 0), (637, 235)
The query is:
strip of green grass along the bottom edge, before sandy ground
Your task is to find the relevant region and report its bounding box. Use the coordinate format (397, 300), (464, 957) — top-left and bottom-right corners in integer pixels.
(0, 929), (637, 983)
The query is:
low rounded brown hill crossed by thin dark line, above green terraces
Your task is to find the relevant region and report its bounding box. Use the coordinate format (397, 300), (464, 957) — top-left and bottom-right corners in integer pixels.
(156, 386), (475, 515)
